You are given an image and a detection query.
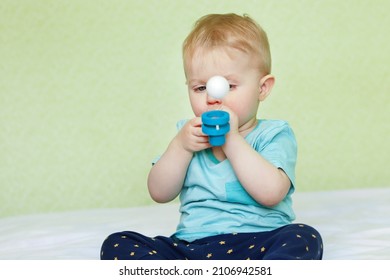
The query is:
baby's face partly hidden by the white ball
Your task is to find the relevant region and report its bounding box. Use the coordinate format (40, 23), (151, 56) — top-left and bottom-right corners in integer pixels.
(185, 49), (262, 129)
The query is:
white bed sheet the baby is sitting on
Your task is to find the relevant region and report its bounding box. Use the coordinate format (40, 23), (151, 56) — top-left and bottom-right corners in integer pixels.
(0, 188), (390, 260)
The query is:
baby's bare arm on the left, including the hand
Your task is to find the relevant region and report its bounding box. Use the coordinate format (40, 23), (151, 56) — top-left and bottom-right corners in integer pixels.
(148, 118), (210, 203)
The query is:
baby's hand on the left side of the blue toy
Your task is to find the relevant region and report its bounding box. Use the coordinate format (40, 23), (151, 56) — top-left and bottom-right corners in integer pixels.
(176, 117), (211, 153)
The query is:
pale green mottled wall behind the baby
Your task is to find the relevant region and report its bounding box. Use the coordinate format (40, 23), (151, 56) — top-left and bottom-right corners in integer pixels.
(0, 0), (390, 216)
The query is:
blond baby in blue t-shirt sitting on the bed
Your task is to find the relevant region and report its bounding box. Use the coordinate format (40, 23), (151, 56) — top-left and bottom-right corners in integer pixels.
(101, 14), (323, 260)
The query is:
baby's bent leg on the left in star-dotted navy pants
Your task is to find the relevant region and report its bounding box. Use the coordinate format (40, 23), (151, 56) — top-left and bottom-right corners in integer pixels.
(100, 231), (184, 260)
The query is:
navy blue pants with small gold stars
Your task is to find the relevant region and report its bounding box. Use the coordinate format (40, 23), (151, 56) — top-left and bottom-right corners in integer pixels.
(100, 224), (323, 260)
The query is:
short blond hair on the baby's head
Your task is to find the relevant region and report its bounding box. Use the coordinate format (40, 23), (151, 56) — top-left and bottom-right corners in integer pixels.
(183, 14), (271, 75)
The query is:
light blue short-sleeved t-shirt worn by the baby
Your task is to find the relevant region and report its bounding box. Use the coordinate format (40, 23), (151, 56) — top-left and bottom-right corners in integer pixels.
(163, 120), (297, 242)
